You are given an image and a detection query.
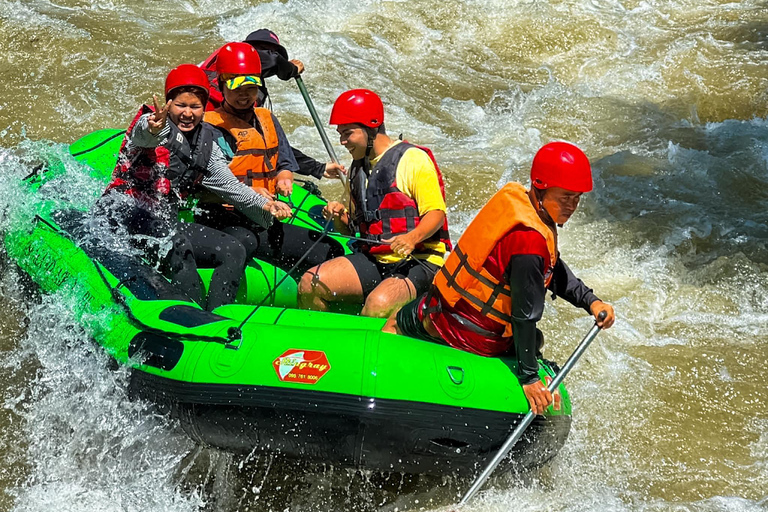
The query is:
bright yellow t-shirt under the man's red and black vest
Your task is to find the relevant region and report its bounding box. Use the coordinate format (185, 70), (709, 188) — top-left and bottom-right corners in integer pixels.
(371, 140), (447, 265)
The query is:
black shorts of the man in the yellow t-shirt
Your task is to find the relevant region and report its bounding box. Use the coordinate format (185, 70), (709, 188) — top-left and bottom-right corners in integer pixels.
(344, 252), (440, 298)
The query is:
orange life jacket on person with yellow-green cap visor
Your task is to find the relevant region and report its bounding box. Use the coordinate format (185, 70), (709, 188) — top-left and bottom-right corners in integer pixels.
(204, 108), (278, 194)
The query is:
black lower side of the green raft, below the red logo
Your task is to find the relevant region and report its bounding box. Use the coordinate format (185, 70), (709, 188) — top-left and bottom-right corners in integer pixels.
(131, 372), (571, 475)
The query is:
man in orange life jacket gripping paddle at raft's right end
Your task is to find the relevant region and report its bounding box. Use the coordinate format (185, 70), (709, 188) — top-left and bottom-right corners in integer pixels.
(383, 142), (615, 414)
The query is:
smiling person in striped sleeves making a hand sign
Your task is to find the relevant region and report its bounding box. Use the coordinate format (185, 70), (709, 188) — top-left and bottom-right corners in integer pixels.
(97, 64), (291, 310)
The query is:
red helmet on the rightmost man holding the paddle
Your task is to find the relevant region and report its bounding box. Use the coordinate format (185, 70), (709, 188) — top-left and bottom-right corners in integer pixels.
(531, 142), (592, 192)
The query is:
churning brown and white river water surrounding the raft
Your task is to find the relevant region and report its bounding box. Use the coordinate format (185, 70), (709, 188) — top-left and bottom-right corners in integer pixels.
(0, 0), (768, 512)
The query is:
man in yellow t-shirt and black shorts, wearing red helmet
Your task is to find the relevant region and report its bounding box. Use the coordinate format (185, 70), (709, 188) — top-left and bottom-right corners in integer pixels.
(299, 89), (450, 317)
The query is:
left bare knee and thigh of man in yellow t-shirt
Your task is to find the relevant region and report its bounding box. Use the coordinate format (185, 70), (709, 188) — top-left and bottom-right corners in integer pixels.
(298, 258), (363, 311)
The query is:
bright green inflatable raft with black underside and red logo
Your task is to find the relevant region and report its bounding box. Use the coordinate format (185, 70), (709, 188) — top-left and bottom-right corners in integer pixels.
(5, 130), (571, 475)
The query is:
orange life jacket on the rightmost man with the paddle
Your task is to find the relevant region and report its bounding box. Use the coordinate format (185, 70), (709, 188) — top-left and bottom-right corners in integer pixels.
(433, 183), (557, 336)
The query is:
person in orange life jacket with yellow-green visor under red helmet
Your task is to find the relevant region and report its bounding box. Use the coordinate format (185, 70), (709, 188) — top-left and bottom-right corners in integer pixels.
(195, 43), (344, 276)
